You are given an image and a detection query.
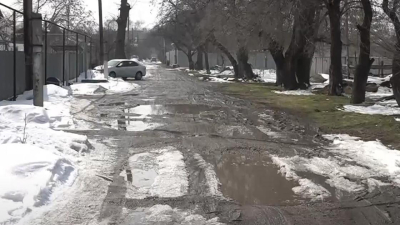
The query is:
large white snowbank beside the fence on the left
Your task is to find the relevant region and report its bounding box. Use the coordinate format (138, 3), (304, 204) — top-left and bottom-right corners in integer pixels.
(0, 85), (88, 223)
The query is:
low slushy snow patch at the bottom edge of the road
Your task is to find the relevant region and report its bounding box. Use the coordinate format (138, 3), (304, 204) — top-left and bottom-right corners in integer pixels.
(121, 205), (223, 225)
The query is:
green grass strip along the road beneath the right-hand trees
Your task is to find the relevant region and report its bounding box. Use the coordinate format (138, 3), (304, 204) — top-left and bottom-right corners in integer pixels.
(224, 84), (400, 150)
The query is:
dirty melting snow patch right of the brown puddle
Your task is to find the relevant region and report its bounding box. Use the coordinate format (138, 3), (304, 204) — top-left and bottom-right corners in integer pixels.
(272, 135), (400, 197)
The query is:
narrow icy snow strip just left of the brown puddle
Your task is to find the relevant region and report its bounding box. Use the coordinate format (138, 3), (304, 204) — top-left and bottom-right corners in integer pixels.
(194, 153), (223, 197)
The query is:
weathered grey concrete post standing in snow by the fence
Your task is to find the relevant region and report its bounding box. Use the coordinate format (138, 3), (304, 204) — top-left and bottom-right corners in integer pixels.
(32, 13), (43, 107)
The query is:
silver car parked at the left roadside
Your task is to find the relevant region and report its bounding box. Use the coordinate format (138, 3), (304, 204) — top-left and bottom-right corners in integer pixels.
(108, 59), (146, 80)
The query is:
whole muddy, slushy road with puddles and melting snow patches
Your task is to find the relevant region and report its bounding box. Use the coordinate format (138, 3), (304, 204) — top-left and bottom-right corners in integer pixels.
(21, 66), (400, 225)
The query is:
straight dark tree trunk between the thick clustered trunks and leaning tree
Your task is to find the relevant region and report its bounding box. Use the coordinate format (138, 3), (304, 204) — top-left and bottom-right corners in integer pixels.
(327, 0), (343, 95)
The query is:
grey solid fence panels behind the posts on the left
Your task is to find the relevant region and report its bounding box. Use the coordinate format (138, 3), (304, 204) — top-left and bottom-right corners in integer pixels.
(0, 51), (84, 100)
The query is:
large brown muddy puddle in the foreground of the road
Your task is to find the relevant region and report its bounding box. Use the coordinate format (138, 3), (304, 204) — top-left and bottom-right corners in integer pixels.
(216, 153), (300, 205)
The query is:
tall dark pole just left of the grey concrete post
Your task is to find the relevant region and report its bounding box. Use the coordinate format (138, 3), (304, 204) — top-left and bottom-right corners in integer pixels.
(23, 0), (33, 90)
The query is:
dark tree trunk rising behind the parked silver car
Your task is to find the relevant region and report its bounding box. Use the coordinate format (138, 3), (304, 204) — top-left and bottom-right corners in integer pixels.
(115, 0), (131, 59)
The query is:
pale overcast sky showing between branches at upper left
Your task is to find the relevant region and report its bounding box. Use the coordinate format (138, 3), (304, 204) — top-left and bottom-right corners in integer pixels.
(0, 0), (158, 28)
